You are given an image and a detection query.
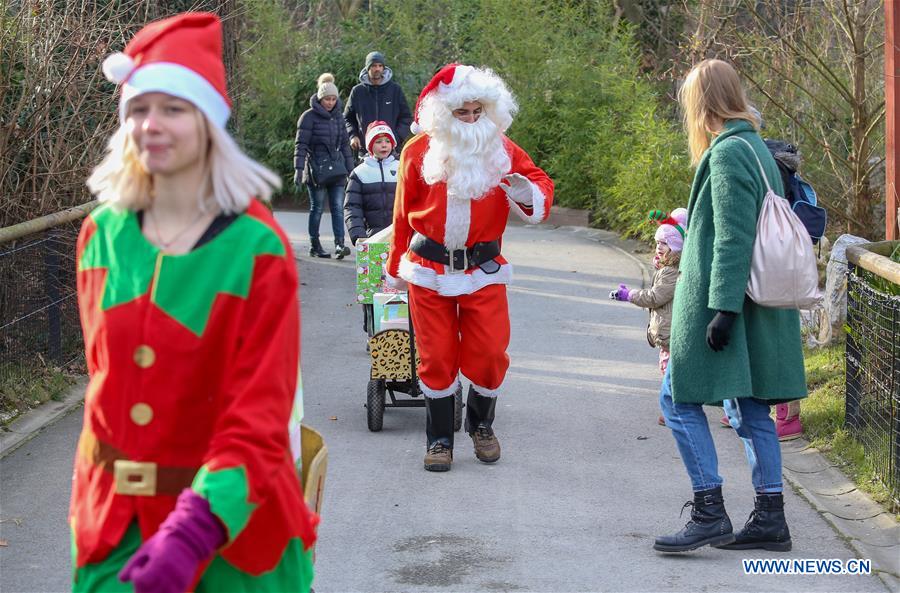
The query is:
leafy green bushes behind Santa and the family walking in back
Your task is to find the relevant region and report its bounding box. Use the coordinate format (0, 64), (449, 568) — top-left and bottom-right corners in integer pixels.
(239, 0), (691, 236)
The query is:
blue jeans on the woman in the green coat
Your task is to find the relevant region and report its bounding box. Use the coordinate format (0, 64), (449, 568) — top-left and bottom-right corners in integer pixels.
(659, 365), (783, 493)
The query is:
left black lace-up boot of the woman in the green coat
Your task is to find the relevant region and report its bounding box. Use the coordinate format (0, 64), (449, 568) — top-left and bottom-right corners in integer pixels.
(653, 486), (734, 552)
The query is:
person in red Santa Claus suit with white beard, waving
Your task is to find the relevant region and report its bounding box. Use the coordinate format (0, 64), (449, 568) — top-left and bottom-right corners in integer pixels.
(387, 64), (553, 471)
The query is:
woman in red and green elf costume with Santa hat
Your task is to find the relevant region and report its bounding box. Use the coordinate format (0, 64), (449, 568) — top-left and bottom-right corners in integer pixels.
(70, 13), (318, 593)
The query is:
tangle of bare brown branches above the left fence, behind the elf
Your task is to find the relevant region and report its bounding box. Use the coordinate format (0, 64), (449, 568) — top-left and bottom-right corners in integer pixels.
(0, 0), (243, 227)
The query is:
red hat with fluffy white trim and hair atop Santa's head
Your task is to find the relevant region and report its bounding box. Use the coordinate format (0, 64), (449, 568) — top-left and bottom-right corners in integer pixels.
(410, 64), (518, 134)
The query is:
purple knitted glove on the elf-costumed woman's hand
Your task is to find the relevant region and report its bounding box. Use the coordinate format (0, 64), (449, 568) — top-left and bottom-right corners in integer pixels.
(119, 488), (225, 593)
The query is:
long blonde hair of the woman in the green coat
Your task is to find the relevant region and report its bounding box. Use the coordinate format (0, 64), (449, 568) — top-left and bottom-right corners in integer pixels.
(678, 60), (759, 166)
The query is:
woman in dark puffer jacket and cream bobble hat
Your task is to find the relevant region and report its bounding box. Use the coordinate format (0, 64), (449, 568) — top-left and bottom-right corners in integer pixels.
(294, 73), (353, 259)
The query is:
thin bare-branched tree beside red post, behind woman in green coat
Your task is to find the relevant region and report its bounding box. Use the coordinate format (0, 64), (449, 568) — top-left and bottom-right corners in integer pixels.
(696, 0), (885, 238)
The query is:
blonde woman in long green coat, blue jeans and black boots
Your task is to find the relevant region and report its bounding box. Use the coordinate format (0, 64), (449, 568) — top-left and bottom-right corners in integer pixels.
(653, 60), (806, 552)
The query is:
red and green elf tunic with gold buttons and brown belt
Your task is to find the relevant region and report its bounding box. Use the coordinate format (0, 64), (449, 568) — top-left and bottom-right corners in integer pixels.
(70, 200), (318, 578)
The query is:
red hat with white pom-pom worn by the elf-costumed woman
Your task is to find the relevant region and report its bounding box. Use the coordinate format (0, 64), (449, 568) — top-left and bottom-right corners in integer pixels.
(103, 12), (231, 128)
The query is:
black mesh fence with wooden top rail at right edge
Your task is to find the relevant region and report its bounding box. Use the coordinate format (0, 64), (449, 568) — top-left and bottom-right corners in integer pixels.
(844, 241), (900, 508)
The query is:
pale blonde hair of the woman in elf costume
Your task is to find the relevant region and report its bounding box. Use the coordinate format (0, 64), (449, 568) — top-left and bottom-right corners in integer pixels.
(87, 108), (281, 214)
